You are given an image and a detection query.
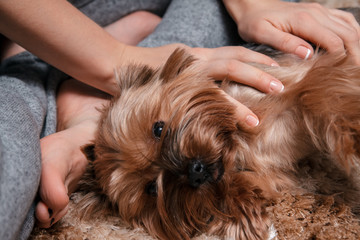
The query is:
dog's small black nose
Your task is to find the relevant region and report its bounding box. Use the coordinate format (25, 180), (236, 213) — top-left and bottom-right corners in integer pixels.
(188, 160), (210, 188)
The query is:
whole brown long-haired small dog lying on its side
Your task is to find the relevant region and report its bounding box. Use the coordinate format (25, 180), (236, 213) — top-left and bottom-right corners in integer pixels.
(78, 49), (360, 239)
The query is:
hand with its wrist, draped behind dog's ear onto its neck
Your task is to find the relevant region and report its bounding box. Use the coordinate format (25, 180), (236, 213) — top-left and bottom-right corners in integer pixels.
(125, 44), (284, 127)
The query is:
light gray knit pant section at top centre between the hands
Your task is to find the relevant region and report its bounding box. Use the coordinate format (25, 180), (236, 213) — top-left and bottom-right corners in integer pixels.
(139, 0), (241, 48)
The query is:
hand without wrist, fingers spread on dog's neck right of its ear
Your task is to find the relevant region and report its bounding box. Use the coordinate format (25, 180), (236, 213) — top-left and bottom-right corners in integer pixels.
(190, 47), (284, 127)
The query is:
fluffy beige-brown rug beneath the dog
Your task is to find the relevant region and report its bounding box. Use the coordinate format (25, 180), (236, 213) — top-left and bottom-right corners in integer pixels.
(30, 0), (360, 240)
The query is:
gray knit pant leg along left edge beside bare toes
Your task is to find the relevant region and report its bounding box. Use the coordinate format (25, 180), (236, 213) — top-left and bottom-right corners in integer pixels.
(0, 52), (64, 240)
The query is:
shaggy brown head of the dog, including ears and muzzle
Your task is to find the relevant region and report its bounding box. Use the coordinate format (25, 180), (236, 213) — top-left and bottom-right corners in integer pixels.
(83, 50), (268, 239)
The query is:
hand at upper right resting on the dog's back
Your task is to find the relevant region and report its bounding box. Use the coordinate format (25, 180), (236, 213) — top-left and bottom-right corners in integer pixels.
(223, 0), (360, 63)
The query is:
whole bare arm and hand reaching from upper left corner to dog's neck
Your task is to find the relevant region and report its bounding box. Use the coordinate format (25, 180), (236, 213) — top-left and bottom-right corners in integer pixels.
(0, 0), (281, 125)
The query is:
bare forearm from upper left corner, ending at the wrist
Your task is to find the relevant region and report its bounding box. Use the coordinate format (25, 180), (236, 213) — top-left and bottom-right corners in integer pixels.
(0, 0), (125, 93)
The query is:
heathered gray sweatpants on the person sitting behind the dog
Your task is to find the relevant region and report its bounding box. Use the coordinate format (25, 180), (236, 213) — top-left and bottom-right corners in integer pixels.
(0, 0), (298, 240)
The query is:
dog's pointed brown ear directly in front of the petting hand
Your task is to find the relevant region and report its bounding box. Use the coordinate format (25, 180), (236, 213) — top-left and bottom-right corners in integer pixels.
(160, 48), (195, 82)
